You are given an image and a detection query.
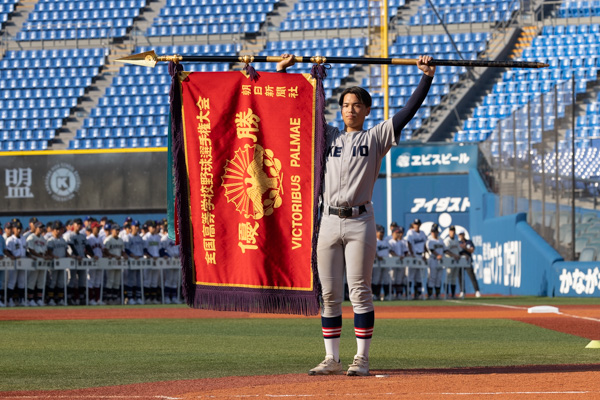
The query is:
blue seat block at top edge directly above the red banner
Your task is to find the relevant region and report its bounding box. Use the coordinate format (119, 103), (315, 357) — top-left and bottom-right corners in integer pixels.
(146, 0), (278, 36)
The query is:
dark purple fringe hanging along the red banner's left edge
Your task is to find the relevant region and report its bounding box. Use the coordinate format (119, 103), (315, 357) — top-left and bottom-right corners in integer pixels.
(169, 62), (196, 306)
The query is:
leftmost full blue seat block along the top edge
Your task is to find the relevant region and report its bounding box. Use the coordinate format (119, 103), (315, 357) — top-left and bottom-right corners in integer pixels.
(17, 0), (146, 41)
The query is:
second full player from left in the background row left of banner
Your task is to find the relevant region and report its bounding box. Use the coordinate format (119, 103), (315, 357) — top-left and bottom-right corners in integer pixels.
(26, 221), (50, 307)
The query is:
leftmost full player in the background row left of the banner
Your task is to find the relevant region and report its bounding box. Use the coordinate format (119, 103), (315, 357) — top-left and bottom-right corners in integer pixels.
(4, 220), (28, 307)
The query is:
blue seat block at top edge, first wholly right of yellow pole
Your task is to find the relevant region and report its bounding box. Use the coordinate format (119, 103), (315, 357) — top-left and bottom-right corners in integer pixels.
(410, 0), (520, 25)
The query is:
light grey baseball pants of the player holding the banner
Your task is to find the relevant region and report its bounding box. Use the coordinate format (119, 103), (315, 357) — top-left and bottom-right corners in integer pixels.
(317, 209), (377, 318)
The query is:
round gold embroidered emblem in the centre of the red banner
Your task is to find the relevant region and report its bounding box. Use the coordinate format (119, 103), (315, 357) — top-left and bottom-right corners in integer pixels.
(221, 144), (283, 220)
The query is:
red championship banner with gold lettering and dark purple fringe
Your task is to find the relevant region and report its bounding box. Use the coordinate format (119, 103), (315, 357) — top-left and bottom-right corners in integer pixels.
(173, 72), (318, 314)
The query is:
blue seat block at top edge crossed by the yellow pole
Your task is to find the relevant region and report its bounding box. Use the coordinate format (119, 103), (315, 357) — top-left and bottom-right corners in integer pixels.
(280, 0), (405, 31)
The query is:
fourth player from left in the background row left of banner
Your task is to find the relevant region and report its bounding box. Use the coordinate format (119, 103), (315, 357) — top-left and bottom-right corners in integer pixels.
(63, 218), (87, 305)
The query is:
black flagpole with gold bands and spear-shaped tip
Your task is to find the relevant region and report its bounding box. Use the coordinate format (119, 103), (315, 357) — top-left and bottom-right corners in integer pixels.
(116, 50), (548, 68)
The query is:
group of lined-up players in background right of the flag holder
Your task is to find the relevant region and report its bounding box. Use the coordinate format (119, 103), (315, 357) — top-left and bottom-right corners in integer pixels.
(372, 219), (481, 300)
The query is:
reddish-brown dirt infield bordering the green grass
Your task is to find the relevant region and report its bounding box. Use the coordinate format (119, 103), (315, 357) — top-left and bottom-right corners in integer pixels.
(0, 302), (600, 400)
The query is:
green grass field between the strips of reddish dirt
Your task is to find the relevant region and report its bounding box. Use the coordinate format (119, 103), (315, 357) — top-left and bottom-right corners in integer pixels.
(0, 298), (600, 391)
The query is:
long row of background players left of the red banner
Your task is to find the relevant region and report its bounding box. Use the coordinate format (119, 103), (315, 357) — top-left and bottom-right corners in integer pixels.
(0, 217), (181, 307)
